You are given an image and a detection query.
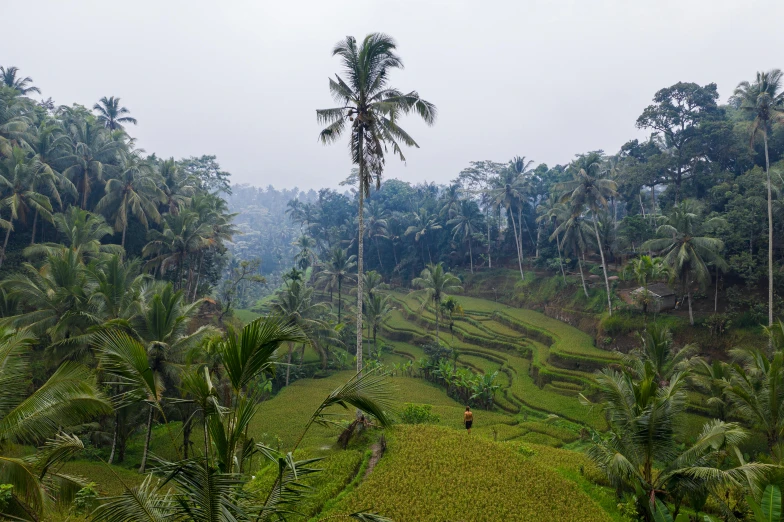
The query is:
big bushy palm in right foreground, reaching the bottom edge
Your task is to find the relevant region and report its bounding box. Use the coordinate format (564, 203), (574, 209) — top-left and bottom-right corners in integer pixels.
(582, 360), (770, 521)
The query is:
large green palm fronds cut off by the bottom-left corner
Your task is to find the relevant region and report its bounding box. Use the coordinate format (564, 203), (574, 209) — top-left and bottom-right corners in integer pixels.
(0, 329), (112, 520)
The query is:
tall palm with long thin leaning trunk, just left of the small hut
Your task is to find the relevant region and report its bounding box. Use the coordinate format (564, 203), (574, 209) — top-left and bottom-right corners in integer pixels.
(559, 152), (618, 316)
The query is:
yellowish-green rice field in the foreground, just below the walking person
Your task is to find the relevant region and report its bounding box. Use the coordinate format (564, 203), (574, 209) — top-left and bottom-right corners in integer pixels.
(324, 426), (613, 522)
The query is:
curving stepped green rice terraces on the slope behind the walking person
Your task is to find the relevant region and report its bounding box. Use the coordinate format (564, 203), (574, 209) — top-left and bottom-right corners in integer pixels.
(382, 292), (617, 426)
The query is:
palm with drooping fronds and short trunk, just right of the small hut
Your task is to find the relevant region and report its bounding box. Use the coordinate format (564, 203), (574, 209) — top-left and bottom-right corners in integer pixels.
(641, 200), (727, 325)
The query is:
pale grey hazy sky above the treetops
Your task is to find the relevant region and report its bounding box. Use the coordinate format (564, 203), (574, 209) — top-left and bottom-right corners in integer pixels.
(6, 0), (784, 188)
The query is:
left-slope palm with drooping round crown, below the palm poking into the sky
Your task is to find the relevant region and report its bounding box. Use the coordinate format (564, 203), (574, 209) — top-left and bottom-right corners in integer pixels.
(95, 151), (165, 248)
